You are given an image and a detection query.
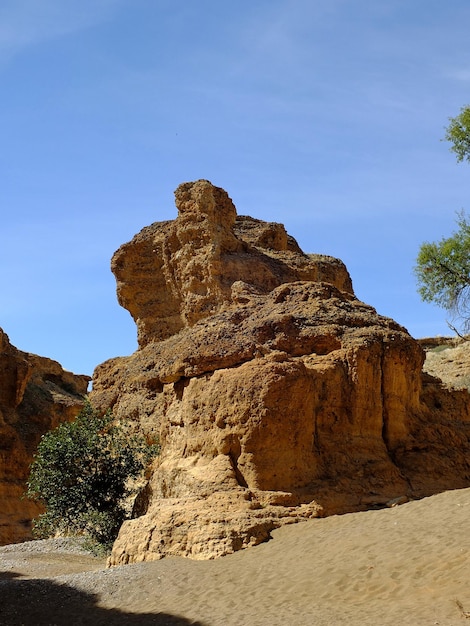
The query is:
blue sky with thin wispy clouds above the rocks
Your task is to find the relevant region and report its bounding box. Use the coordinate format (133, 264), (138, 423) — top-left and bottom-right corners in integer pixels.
(0, 0), (470, 374)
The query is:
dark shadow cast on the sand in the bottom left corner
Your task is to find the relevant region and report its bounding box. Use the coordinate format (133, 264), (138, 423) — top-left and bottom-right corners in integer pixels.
(0, 572), (204, 626)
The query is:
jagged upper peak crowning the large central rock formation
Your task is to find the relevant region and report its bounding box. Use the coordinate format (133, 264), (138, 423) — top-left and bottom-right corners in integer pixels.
(111, 180), (352, 347)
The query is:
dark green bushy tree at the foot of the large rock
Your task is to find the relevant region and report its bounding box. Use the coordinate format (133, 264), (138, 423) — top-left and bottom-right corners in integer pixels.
(26, 401), (158, 549)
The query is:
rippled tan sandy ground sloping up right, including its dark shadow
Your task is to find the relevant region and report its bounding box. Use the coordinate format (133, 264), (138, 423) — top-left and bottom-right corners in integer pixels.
(0, 489), (470, 626)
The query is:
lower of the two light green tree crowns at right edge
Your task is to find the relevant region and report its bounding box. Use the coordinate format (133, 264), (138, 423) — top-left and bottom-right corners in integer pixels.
(415, 212), (470, 331)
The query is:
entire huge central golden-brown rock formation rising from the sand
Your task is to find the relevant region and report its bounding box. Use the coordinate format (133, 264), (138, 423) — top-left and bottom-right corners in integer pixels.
(91, 181), (470, 564)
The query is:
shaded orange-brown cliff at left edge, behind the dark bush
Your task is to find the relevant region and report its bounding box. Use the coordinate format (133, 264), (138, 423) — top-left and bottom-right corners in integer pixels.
(0, 329), (90, 545)
